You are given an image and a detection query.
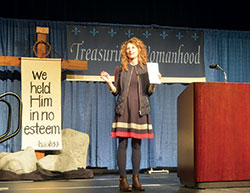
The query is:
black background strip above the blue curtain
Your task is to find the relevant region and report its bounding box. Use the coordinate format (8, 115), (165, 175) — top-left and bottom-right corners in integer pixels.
(0, 0), (250, 31)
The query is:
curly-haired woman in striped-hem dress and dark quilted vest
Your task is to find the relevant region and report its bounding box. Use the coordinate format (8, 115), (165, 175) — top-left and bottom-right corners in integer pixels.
(101, 37), (161, 192)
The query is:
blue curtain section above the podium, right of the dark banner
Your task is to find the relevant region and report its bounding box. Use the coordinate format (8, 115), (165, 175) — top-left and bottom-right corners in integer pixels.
(204, 30), (250, 82)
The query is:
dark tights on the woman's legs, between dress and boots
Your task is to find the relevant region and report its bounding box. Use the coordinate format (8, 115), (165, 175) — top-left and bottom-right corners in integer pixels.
(117, 137), (141, 176)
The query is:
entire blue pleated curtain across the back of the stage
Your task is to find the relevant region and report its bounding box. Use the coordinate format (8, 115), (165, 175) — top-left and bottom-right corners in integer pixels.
(0, 18), (250, 169)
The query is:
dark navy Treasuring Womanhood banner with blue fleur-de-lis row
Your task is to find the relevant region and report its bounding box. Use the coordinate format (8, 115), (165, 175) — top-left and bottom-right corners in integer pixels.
(67, 25), (206, 82)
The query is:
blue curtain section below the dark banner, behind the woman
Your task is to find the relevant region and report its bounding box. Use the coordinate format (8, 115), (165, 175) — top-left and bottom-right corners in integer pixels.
(62, 81), (186, 169)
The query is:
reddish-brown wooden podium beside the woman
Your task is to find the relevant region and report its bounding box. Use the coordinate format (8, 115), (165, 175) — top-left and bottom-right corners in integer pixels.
(178, 83), (250, 187)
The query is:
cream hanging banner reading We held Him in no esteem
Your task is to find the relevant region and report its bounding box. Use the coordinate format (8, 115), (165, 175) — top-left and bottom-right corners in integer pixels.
(21, 58), (62, 150)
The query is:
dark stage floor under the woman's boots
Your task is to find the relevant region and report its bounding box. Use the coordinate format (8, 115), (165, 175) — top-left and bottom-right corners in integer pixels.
(0, 172), (250, 193)
